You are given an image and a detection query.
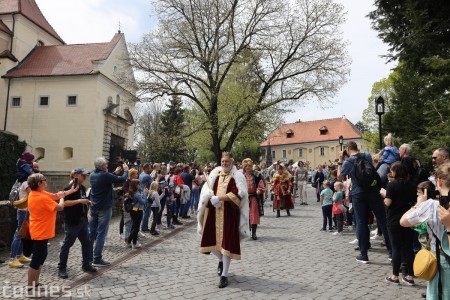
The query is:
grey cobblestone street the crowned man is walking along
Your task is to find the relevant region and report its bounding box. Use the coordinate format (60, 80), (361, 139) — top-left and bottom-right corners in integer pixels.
(0, 188), (425, 300)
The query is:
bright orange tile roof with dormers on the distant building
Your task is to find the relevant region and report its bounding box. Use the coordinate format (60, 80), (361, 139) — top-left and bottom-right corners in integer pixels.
(260, 117), (362, 147)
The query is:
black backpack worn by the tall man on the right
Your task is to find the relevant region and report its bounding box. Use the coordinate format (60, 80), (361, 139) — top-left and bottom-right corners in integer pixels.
(349, 153), (381, 190)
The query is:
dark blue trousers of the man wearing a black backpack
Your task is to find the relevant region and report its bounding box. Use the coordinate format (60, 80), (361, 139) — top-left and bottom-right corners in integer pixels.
(352, 191), (392, 258)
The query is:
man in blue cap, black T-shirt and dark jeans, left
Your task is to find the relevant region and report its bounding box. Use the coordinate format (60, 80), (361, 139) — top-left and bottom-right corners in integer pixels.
(58, 168), (97, 278)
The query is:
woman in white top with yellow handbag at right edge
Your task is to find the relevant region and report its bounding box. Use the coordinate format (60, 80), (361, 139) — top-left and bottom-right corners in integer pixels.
(400, 163), (450, 300)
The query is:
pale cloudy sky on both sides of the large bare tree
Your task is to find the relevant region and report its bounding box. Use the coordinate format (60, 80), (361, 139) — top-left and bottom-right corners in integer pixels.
(36, 0), (394, 123)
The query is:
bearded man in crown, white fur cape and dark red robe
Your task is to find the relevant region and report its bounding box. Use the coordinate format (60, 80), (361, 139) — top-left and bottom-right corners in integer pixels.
(197, 152), (249, 288)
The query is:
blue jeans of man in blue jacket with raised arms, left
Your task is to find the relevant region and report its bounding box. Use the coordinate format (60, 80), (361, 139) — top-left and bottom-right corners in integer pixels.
(89, 208), (112, 261)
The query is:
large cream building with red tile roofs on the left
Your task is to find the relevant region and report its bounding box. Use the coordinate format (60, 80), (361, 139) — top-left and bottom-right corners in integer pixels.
(0, 0), (136, 171)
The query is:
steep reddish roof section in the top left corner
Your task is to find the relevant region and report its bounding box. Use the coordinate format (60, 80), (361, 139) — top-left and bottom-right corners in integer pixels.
(0, 0), (65, 44)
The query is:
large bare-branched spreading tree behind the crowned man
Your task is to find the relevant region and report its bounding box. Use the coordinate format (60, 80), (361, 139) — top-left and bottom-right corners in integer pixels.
(130, 0), (350, 159)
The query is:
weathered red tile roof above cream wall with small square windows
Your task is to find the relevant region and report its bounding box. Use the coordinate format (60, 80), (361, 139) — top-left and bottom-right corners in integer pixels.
(3, 33), (123, 78)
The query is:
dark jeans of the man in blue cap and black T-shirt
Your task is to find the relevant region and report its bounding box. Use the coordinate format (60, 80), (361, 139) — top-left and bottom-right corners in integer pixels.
(58, 218), (90, 269)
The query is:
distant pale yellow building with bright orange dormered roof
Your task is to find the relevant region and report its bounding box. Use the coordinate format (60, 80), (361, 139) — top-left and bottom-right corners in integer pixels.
(260, 117), (366, 168)
